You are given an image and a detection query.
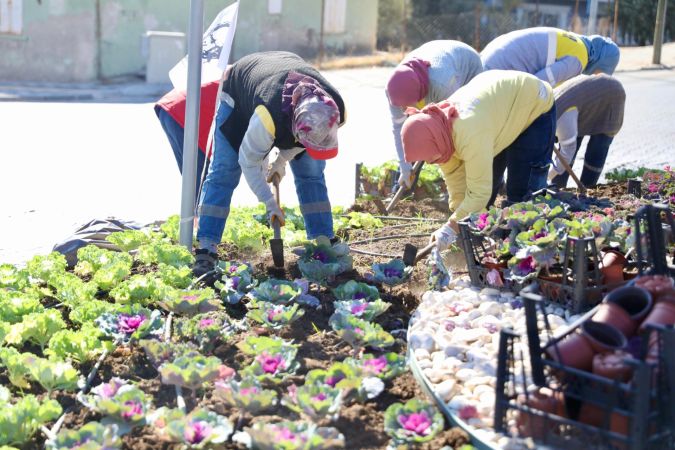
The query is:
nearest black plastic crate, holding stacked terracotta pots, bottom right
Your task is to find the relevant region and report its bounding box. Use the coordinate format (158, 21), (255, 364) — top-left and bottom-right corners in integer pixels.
(494, 294), (675, 450)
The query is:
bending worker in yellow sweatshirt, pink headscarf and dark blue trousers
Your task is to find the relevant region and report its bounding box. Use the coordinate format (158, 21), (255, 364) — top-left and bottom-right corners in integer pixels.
(401, 70), (555, 250)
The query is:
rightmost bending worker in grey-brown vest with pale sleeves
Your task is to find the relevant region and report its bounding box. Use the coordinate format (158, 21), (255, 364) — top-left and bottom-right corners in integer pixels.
(549, 74), (626, 187)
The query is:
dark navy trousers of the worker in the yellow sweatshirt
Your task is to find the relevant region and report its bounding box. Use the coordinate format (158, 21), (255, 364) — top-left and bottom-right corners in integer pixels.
(488, 105), (555, 206)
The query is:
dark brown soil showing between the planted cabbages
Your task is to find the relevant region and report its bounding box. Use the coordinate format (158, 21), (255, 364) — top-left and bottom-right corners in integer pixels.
(14, 200), (468, 450)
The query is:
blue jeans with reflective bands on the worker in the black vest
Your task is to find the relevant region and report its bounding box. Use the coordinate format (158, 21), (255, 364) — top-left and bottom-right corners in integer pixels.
(197, 101), (334, 248)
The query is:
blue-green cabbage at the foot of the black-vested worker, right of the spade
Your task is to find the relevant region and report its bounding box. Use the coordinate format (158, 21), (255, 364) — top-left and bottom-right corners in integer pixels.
(298, 236), (353, 284)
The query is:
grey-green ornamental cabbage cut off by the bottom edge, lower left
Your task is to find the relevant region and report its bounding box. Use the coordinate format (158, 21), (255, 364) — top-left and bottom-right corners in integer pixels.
(45, 422), (122, 450)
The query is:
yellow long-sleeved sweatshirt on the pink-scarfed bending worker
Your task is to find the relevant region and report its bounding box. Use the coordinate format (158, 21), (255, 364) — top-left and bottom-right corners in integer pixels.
(440, 70), (553, 220)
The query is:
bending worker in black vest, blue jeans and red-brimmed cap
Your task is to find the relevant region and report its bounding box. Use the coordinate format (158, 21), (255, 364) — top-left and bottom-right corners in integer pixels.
(193, 51), (345, 276)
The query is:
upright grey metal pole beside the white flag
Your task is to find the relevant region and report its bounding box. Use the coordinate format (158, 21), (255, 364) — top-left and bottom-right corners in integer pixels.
(179, 0), (204, 249)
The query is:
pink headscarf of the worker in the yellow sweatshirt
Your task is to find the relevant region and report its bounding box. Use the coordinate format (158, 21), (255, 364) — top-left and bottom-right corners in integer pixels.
(401, 101), (459, 164)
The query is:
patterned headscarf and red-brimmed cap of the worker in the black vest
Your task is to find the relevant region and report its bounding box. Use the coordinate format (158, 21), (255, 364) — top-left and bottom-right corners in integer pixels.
(282, 72), (340, 159)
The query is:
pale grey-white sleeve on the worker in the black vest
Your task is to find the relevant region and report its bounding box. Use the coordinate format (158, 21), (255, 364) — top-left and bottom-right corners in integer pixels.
(239, 111), (274, 205)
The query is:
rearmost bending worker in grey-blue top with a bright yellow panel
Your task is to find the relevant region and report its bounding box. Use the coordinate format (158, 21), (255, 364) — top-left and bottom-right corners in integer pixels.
(481, 27), (619, 87)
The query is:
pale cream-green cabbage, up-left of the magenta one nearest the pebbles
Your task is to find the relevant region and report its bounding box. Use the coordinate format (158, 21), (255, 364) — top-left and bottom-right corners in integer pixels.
(281, 384), (343, 423)
